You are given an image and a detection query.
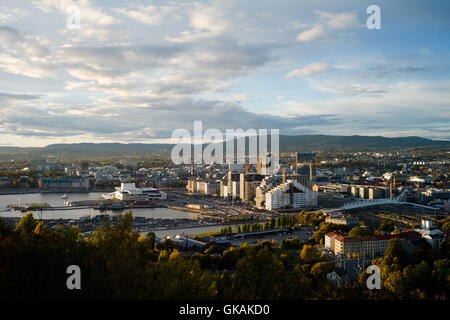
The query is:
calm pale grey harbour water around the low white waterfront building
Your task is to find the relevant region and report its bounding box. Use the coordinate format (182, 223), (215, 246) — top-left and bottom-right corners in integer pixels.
(0, 192), (195, 219)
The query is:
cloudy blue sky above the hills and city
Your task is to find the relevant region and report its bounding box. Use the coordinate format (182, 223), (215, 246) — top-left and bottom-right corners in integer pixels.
(0, 0), (450, 147)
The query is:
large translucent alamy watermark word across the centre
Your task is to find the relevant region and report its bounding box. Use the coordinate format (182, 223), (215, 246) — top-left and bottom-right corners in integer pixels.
(171, 121), (280, 174)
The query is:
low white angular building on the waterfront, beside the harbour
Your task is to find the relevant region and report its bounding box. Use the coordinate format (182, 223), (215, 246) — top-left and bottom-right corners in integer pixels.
(105, 183), (167, 201)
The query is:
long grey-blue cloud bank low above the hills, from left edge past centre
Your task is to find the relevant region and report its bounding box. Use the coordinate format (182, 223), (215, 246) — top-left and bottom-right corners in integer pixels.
(1, 92), (338, 142)
